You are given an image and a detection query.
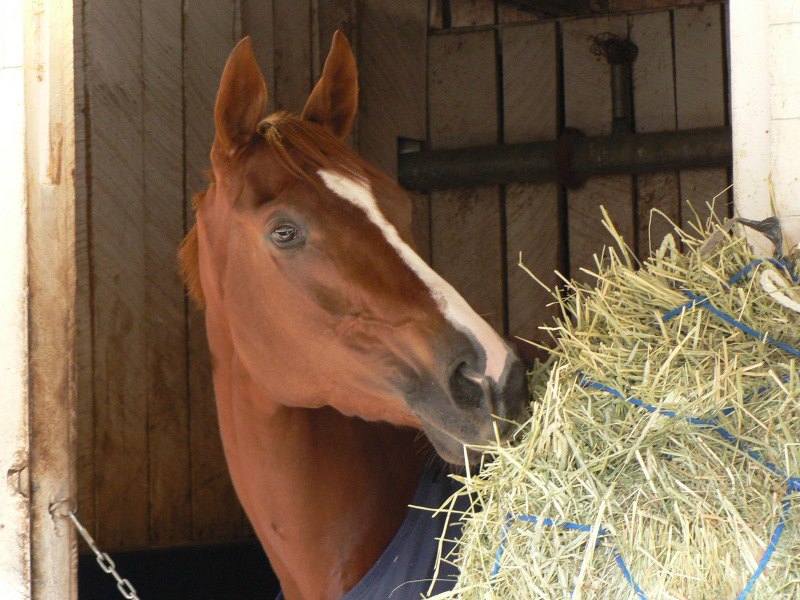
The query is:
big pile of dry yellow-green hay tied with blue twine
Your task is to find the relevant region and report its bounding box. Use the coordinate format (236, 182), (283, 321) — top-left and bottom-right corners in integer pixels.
(437, 209), (800, 600)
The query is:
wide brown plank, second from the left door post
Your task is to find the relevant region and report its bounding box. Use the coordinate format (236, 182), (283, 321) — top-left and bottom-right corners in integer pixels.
(85, 0), (149, 549)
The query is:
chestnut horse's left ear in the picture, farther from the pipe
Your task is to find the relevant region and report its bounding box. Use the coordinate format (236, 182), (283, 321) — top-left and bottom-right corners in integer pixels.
(214, 37), (267, 152)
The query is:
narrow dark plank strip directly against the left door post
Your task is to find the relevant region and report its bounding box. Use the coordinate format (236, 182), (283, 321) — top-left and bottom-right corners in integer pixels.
(73, 0), (96, 550)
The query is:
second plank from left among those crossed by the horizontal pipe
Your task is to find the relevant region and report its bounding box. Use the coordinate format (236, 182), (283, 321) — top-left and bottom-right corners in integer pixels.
(501, 22), (562, 342)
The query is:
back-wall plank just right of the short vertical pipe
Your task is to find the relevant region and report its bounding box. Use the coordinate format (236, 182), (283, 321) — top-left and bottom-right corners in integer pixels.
(631, 11), (681, 257)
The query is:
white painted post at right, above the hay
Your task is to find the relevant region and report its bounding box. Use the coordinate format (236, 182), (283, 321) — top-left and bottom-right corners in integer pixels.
(730, 0), (800, 253)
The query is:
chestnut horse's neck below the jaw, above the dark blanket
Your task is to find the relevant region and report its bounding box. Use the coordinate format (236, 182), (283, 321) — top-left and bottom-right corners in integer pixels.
(209, 312), (427, 600)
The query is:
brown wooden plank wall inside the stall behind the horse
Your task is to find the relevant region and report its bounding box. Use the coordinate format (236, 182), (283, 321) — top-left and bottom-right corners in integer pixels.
(75, 0), (727, 550)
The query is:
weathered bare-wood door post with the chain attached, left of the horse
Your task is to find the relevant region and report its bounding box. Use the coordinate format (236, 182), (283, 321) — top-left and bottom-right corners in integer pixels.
(26, 0), (78, 599)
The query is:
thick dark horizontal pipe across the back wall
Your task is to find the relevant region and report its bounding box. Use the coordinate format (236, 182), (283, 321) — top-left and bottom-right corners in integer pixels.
(398, 127), (732, 191)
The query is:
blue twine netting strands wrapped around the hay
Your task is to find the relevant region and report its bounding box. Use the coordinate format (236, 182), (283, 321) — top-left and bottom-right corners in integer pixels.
(492, 258), (800, 600)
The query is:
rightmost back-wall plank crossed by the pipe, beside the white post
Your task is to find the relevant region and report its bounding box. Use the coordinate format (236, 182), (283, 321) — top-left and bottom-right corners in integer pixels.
(674, 6), (729, 230)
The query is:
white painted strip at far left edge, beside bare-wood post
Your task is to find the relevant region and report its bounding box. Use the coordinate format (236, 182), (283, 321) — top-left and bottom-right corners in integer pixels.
(0, 0), (31, 600)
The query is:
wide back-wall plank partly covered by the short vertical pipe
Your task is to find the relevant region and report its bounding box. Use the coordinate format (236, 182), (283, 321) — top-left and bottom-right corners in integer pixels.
(563, 16), (636, 280)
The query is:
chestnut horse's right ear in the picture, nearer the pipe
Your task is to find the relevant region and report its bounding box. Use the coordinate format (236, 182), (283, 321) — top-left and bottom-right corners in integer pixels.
(303, 30), (358, 138)
